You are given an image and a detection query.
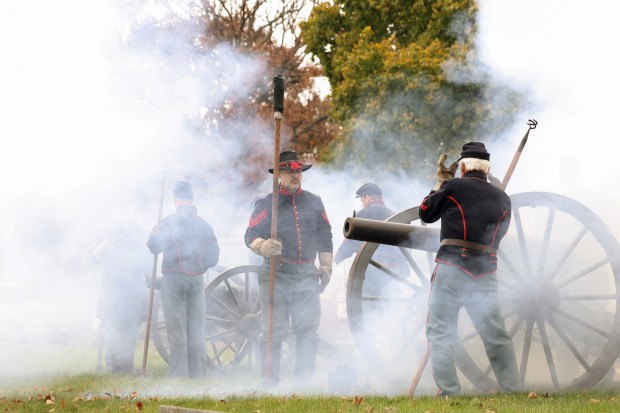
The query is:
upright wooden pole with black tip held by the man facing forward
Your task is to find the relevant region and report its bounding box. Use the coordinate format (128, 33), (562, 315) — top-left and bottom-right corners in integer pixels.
(265, 75), (284, 384)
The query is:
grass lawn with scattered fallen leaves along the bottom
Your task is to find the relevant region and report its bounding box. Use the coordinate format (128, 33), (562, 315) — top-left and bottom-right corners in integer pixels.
(0, 340), (620, 413)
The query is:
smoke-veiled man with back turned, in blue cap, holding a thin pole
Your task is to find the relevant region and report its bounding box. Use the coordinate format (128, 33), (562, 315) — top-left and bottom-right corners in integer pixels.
(147, 181), (220, 378)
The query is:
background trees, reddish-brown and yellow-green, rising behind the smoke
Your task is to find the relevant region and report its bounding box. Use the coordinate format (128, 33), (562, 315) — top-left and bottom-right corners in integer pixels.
(134, 0), (523, 183)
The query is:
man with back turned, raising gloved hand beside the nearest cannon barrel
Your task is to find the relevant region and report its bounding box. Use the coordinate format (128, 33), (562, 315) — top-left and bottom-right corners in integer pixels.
(420, 142), (520, 396)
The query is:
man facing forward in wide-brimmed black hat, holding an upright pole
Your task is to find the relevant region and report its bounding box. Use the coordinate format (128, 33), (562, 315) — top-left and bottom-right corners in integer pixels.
(245, 151), (333, 385)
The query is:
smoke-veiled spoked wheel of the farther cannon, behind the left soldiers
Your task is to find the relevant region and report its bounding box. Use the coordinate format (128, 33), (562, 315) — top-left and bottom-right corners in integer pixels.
(153, 265), (261, 371)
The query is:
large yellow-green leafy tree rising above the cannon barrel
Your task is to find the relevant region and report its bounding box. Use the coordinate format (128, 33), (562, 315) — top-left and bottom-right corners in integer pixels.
(301, 0), (520, 180)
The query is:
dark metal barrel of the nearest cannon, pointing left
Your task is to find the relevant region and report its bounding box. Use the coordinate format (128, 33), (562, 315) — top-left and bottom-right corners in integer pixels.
(343, 217), (439, 252)
